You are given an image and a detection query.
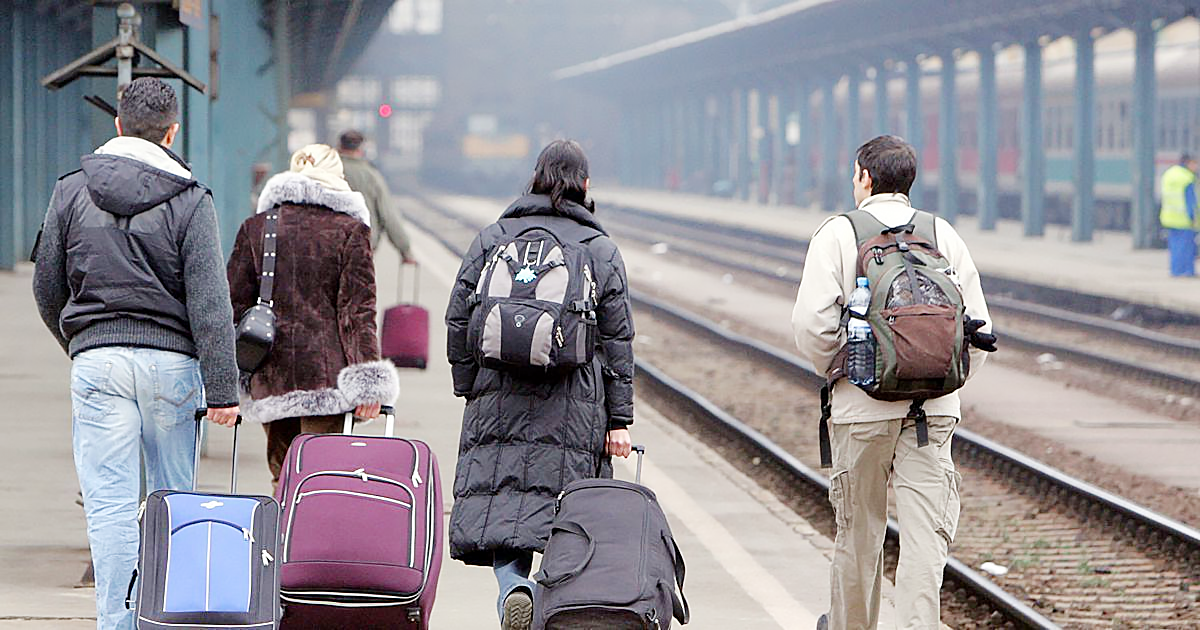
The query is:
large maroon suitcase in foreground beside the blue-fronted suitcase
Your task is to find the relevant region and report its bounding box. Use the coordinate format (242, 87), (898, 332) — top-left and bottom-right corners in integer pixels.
(276, 407), (443, 630)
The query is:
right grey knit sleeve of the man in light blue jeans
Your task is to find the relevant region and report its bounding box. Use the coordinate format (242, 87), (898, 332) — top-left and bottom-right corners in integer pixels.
(182, 193), (238, 407)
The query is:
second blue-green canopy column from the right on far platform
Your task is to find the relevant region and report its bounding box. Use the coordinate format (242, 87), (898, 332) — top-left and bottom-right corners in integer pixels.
(1070, 28), (1096, 241)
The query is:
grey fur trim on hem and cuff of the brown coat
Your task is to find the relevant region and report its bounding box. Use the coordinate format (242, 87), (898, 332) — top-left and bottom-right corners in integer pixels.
(239, 357), (400, 424)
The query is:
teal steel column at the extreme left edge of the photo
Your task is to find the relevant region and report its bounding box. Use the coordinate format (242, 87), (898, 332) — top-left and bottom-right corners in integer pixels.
(0, 2), (24, 269)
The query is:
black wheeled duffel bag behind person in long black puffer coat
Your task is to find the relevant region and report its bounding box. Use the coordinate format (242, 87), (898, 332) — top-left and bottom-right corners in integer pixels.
(533, 446), (690, 630)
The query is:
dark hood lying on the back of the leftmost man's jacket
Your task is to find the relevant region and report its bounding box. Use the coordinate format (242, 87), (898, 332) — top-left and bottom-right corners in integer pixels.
(80, 149), (198, 216)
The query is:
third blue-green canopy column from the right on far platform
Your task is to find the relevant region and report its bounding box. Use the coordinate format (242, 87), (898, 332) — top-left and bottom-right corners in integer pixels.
(1021, 42), (1046, 236)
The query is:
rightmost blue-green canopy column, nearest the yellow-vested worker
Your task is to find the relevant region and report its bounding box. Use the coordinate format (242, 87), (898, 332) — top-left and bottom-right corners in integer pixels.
(1129, 16), (1158, 250)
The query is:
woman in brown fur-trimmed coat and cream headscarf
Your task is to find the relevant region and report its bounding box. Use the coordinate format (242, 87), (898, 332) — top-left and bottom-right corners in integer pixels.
(228, 144), (400, 484)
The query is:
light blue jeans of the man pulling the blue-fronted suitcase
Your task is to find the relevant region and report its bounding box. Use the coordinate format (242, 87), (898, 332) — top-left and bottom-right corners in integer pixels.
(71, 347), (204, 630)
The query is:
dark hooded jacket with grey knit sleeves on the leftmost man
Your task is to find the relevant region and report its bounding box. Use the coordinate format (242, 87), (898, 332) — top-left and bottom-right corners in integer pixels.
(34, 140), (238, 407)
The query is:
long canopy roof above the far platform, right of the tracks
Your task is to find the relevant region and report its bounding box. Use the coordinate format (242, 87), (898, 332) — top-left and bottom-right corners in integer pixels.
(553, 0), (1200, 92)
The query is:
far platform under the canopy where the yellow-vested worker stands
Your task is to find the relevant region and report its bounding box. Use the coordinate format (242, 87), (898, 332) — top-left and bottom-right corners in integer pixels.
(593, 186), (1200, 316)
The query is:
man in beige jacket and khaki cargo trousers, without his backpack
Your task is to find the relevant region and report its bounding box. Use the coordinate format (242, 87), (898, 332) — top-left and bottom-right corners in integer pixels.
(792, 136), (995, 630)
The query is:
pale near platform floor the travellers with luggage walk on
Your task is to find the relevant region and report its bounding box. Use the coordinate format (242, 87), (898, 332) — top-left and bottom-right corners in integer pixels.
(0, 218), (892, 630)
